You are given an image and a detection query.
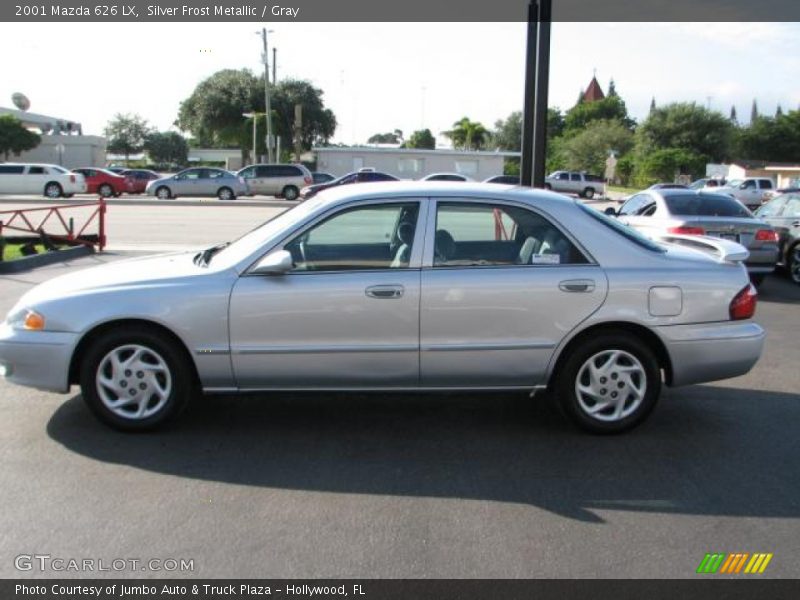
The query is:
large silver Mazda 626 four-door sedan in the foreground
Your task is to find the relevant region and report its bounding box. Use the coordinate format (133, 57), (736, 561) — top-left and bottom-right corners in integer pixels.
(0, 183), (764, 432)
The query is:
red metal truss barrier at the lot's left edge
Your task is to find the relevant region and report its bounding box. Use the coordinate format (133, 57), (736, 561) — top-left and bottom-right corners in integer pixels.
(0, 198), (106, 250)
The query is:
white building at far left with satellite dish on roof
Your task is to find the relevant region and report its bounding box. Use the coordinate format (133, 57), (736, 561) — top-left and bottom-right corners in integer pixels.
(0, 107), (106, 169)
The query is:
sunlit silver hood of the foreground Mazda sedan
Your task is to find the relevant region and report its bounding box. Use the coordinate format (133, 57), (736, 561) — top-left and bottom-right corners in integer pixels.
(17, 252), (209, 307)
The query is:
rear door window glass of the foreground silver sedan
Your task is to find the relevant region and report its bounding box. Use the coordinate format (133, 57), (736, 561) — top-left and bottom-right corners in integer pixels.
(433, 202), (588, 267)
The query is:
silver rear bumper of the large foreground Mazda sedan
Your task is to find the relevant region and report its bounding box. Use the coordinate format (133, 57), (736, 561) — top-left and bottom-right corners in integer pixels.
(657, 321), (766, 386)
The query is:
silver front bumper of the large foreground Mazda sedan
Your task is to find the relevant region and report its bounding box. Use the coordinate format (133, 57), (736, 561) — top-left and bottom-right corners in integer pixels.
(0, 323), (78, 393)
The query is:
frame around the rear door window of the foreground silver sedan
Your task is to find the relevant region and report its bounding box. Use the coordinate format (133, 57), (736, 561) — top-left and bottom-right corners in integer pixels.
(422, 196), (599, 271)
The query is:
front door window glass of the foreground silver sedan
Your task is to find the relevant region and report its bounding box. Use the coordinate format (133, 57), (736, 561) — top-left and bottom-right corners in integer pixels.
(284, 202), (419, 271)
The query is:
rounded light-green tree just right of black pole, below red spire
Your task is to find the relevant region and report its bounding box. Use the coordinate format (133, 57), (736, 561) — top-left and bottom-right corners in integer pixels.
(561, 120), (633, 175)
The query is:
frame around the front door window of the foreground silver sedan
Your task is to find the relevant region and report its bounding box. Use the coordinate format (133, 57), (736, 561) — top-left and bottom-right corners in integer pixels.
(241, 196), (427, 277)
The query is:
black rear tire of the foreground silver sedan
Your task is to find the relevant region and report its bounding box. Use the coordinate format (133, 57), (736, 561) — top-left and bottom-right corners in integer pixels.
(554, 331), (661, 434)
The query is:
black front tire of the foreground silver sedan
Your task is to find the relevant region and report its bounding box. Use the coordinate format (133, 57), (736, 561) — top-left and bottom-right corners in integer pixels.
(79, 326), (199, 432)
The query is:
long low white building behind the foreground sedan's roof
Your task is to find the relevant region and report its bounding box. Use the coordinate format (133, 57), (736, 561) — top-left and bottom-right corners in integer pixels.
(313, 148), (519, 181)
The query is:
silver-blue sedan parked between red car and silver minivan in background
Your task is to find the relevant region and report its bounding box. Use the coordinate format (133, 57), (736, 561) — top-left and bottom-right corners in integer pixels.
(145, 167), (249, 200)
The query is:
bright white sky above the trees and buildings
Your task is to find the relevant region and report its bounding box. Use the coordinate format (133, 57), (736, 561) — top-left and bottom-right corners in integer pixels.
(0, 22), (800, 144)
